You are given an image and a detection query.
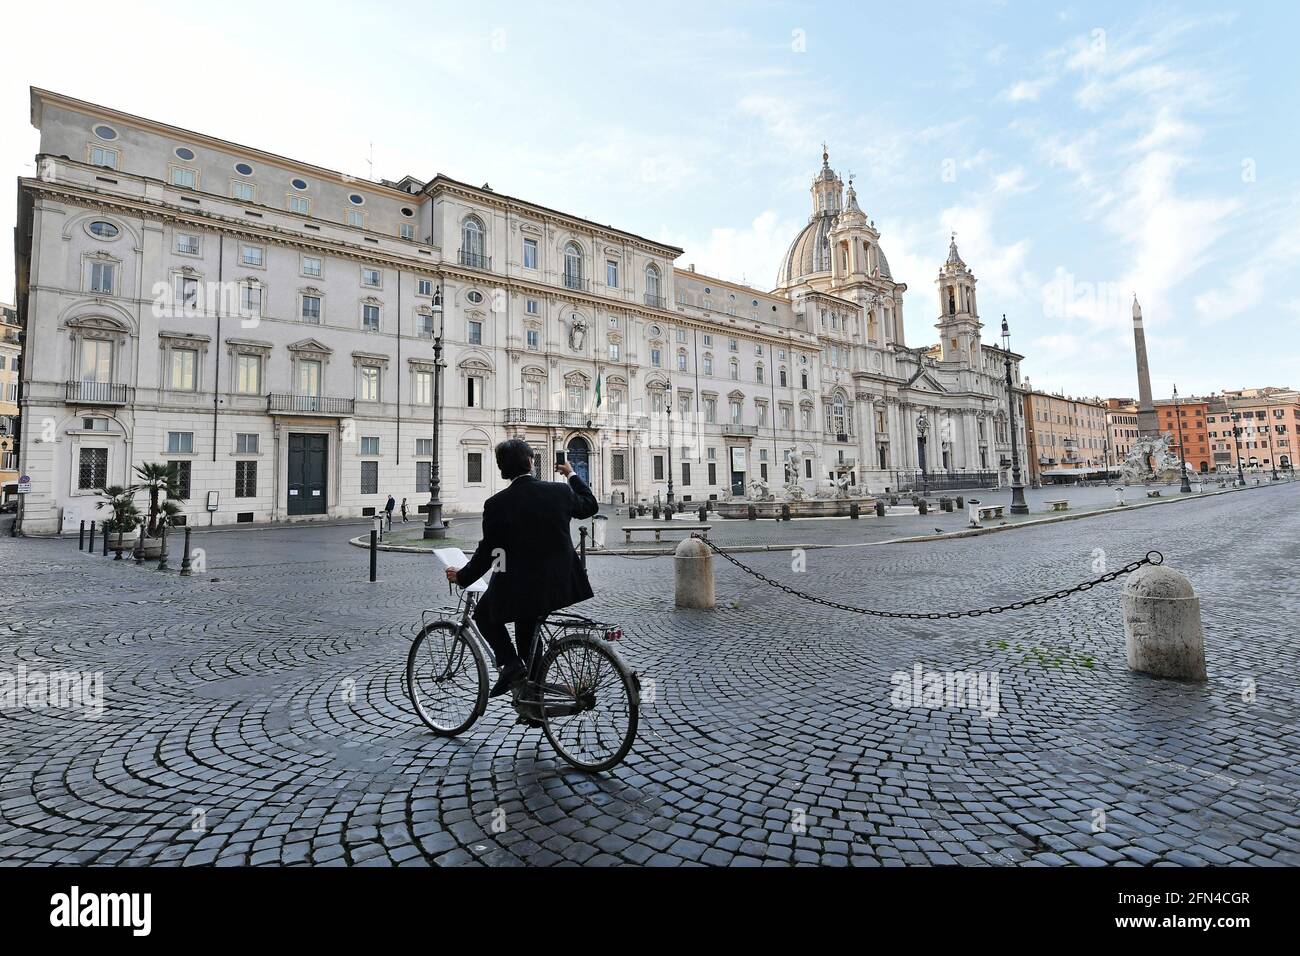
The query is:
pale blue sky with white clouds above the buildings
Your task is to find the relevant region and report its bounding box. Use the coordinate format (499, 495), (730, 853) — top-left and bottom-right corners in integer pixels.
(0, 0), (1300, 395)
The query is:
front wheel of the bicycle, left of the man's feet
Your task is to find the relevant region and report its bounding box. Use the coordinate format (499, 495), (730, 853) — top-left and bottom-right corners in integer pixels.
(407, 620), (488, 737)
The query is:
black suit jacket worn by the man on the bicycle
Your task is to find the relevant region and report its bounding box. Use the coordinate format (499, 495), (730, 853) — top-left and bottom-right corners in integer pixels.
(456, 475), (599, 623)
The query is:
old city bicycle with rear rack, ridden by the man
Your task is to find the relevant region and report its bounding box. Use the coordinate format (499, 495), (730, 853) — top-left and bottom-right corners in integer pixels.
(406, 591), (641, 773)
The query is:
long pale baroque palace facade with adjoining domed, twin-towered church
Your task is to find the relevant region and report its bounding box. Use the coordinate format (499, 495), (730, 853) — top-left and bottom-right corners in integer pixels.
(16, 90), (1026, 533)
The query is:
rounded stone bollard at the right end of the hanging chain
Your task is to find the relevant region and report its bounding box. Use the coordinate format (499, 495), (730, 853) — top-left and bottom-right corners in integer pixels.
(1119, 564), (1205, 680)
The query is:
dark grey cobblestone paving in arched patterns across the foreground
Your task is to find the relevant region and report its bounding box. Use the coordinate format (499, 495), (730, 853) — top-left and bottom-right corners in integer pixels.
(0, 484), (1300, 866)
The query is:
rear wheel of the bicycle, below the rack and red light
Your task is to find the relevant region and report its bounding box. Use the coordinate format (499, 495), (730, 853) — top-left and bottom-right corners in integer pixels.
(540, 633), (641, 771)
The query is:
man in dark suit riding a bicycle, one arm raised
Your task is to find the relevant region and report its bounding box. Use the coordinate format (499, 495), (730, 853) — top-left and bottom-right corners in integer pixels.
(447, 438), (599, 697)
